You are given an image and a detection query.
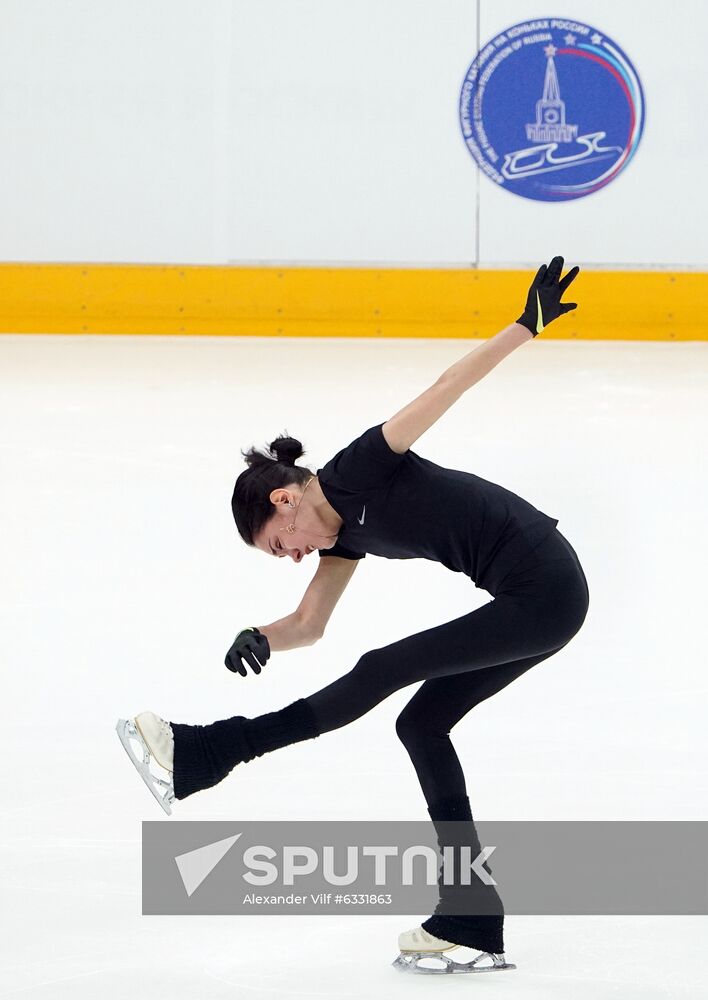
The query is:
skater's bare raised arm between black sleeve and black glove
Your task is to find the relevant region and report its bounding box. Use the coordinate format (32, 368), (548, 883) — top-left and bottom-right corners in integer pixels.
(382, 323), (533, 455)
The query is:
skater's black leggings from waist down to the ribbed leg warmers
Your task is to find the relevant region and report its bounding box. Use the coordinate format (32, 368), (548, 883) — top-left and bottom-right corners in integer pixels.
(307, 528), (589, 805)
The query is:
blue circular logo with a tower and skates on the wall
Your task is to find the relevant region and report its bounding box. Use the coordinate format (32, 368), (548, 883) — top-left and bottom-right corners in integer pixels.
(460, 18), (645, 201)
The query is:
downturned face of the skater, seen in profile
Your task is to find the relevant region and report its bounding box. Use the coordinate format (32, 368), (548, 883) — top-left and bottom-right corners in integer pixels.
(254, 480), (342, 562)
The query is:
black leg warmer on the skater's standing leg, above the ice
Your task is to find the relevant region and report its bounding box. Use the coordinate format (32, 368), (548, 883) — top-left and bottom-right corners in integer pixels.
(422, 795), (504, 955)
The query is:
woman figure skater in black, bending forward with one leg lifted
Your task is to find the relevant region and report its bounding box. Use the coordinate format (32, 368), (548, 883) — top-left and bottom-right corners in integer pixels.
(116, 257), (589, 972)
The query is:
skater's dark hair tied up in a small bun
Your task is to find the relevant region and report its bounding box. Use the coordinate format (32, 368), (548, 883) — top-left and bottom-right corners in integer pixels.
(231, 431), (315, 546)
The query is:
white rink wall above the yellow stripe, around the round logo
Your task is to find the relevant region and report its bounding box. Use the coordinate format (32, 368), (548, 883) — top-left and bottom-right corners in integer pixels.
(0, 0), (708, 267)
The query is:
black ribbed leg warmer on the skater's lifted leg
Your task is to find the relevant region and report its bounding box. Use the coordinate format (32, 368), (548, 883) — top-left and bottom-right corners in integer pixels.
(170, 698), (320, 799)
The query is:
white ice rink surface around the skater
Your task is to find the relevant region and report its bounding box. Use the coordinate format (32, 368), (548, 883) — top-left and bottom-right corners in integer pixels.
(0, 336), (708, 1000)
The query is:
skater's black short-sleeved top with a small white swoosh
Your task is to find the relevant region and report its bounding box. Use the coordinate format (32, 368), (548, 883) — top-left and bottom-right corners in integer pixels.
(317, 424), (558, 595)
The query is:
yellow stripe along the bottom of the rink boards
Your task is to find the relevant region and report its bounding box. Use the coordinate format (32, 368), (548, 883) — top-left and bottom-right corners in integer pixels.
(0, 264), (708, 340)
